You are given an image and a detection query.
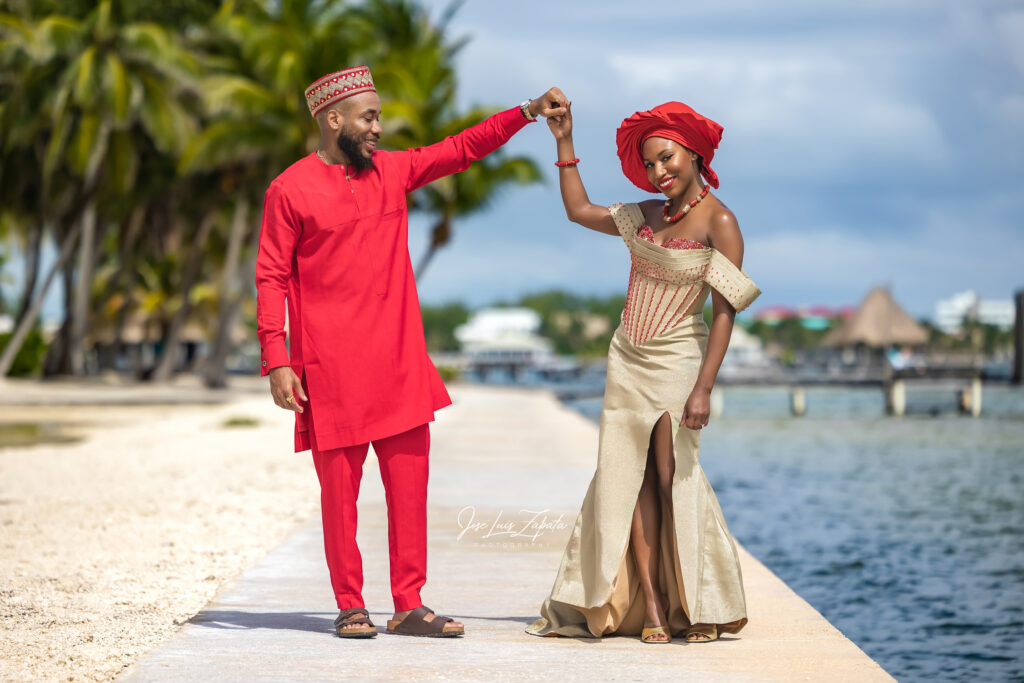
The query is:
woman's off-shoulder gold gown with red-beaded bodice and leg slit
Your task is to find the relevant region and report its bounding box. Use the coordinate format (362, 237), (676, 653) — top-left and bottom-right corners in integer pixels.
(526, 204), (761, 637)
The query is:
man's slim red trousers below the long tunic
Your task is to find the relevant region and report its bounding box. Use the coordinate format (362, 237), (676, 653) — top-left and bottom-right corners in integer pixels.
(306, 404), (430, 611)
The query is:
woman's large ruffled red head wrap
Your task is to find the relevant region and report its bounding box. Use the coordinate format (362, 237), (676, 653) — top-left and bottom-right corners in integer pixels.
(615, 102), (722, 193)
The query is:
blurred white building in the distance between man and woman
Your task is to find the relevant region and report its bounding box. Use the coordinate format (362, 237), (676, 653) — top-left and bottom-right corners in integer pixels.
(455, 308), (554, 366)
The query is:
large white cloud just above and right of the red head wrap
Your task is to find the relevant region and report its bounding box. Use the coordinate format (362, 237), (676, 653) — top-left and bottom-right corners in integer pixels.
(608, 43), (949, 181)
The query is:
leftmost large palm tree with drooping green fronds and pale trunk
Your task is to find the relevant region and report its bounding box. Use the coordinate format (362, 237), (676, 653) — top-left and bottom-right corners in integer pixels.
(0, 0), (197, 374)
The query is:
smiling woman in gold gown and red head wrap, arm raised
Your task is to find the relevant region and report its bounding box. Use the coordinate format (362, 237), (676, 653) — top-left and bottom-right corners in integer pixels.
(526, 102), (760, 643)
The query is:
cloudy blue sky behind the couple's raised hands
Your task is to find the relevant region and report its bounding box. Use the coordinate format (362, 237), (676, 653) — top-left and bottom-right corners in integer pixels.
(407, 0), (1024, 316)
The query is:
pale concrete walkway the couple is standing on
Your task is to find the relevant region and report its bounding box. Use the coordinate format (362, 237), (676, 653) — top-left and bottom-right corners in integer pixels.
(124, 387), (893, 682)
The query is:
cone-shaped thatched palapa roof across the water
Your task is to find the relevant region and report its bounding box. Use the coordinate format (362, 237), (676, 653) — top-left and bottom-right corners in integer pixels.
(824, 287), (928, 346)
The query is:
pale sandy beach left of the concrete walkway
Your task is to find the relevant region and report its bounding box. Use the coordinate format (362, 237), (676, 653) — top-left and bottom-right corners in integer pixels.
(0, 378), (318, 681)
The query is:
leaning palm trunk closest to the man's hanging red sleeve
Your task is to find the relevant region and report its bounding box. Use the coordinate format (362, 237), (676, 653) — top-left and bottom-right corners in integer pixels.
(205, 199), (250, 389)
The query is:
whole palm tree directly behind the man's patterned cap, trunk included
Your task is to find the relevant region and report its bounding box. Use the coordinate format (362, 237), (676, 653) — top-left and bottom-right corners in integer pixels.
(179, 0), (358, 387)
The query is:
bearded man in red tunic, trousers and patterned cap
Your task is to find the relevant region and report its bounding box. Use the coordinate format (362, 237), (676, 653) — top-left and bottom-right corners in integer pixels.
(256, 67), (566, 637)
